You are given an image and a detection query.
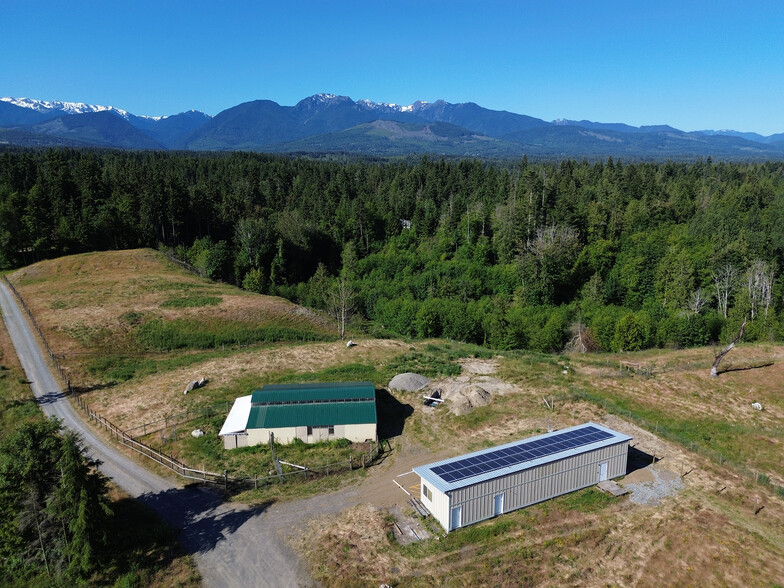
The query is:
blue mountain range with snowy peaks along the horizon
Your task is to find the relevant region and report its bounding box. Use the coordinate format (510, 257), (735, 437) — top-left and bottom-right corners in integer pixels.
(0, 94), (784, 160)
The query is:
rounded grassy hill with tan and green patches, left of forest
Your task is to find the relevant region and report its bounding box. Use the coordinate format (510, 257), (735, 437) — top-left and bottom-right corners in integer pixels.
(9, 249), (334, 386)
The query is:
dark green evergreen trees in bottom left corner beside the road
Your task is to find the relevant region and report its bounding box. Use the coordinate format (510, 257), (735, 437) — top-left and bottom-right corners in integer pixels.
(0, 419), (112, 585)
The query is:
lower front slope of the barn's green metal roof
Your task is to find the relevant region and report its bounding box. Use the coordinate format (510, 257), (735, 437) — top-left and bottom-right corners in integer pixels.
(247, 400), (376, 429)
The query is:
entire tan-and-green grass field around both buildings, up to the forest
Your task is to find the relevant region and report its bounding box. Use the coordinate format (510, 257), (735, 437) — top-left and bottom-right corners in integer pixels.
(6, 251), (784, 586)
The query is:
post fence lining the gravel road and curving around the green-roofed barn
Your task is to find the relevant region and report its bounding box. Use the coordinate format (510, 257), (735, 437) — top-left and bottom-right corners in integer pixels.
(2, 276), (383, 490)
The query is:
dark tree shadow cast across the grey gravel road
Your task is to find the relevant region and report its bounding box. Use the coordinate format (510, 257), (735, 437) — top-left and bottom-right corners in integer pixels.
(138, 486), (271, 553)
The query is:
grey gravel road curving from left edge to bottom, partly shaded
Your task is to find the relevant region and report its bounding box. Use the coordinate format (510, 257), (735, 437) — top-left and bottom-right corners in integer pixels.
(0, 281), (322, 587)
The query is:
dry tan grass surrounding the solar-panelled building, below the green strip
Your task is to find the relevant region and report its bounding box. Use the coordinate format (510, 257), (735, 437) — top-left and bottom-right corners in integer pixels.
(297, 417), (784, 586)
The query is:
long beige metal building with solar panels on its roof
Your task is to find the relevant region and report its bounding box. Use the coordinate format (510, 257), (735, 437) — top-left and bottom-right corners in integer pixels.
(414, 423), (632, 531)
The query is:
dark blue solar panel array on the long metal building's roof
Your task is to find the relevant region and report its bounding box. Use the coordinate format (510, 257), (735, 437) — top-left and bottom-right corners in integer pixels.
(432, 426), (613, 483)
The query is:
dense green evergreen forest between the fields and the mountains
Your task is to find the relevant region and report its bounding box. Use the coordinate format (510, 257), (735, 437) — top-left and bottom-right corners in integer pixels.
(0, 149), (784, 352)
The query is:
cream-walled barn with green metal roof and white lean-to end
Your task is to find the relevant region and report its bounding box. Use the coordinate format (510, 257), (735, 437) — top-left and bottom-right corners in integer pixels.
(219, 382), (378, 449)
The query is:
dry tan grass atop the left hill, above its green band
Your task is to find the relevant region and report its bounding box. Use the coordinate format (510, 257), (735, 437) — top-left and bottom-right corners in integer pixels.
(8, 249), (334, 368)
